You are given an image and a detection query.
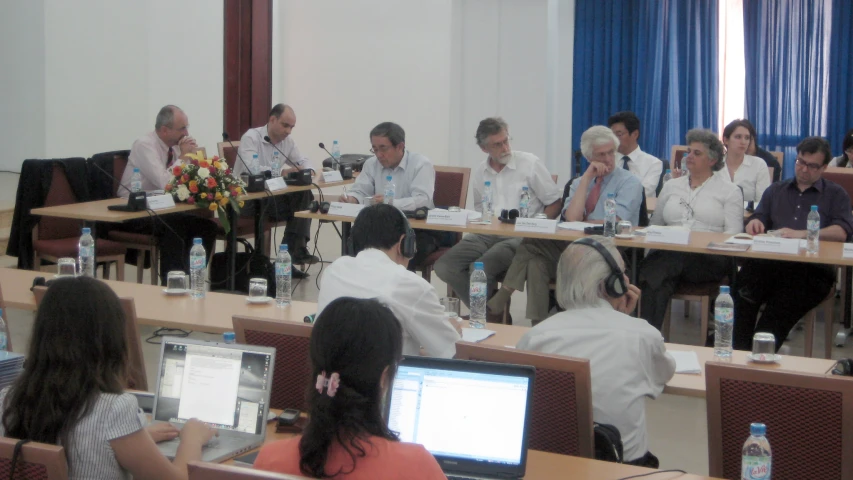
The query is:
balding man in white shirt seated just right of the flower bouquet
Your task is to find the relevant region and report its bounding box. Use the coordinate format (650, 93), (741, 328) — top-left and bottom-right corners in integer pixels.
(234, 103), (318, 264)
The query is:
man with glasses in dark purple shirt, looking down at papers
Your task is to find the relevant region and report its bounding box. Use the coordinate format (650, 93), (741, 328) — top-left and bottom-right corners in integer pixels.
(732, 137), (853, 351)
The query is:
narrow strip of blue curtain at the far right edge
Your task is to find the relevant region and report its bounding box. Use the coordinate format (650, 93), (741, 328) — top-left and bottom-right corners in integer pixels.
(826, 0), (853, 155)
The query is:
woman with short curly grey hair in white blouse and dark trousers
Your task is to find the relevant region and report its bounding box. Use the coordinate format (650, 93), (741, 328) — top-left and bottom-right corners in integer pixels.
(640, 129), (740, 329)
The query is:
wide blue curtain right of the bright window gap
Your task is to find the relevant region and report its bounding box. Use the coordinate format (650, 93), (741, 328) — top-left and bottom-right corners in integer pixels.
(743, 0), (832, 178)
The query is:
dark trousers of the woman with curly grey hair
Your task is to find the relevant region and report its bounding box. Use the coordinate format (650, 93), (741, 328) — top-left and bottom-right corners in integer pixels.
(640, 250), (731, 330)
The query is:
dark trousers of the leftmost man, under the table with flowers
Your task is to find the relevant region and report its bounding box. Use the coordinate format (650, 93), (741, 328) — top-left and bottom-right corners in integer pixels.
(113, 213), (216, 285)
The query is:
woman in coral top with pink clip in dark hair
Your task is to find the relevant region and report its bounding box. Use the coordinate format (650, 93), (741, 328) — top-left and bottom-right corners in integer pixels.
(255, 297), (445, 480)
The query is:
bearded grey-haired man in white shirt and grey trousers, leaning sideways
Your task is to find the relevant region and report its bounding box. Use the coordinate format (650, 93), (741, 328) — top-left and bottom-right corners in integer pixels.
(435, 117), (562, 320)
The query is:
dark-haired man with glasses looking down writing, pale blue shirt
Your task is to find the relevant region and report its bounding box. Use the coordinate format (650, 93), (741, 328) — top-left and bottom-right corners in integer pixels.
(338, 122), (442, 270)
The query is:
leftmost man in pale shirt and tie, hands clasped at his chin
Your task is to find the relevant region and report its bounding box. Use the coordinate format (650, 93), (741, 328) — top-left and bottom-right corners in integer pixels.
(113, 105), (217, 285)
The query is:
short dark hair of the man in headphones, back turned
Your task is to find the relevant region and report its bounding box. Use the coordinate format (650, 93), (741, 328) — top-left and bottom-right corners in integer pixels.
(350, 203), (408, 255)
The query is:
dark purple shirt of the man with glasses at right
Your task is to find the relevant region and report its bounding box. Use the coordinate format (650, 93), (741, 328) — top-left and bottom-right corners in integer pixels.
(753, 178), (853, 240)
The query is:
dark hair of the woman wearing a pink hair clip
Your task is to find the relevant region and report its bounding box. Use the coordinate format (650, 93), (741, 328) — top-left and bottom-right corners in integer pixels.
(299, 298), (403, 478)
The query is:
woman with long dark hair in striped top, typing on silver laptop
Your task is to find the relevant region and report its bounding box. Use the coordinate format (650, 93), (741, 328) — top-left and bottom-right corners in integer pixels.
(0, 277), (213, 479)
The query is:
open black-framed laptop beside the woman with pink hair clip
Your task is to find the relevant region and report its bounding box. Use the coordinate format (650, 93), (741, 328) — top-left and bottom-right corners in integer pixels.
(386, 357), (535, 480)
